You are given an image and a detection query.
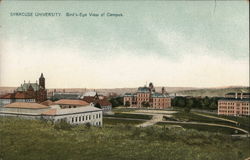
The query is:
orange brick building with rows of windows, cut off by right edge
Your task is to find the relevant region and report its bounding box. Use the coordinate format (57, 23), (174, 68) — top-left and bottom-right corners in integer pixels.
(218, 93), (250, 116)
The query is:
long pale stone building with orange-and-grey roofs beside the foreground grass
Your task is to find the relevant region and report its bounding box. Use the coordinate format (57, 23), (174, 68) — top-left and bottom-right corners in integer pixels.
(0, 102), (103, 126)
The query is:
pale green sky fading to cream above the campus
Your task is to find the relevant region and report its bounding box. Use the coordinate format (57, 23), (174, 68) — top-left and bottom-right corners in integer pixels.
(0, 0), (249, 88)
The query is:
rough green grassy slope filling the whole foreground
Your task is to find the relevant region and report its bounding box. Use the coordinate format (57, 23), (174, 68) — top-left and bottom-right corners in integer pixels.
(0, 117), (250, 160)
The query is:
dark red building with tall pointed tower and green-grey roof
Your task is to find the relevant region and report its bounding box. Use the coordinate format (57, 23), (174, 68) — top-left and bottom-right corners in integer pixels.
(0, 73), (47, 106)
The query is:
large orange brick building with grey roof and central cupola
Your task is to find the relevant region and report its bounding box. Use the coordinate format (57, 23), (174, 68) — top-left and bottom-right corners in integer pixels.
(123, 83), (171, 109)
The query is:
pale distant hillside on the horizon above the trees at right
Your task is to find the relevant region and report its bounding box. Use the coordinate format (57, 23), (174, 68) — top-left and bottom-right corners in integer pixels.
(176, 87), (250, 97)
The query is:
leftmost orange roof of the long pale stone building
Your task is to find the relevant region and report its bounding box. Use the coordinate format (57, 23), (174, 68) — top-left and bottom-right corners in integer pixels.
(3, 102), (49, 109)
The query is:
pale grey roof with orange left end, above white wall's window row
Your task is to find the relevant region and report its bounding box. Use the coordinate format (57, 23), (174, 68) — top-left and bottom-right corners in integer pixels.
(42, 106), (102, 115)
